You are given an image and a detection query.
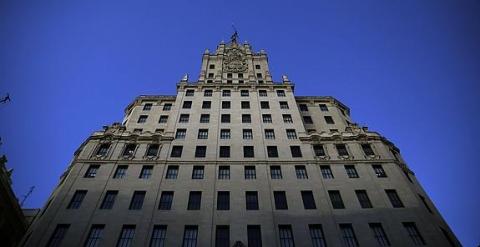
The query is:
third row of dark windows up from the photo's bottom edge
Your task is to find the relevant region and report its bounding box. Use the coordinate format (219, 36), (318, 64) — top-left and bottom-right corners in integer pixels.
(84, 165), (387, 179)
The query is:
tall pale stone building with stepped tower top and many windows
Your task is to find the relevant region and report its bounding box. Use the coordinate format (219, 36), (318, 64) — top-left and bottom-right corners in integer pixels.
(24, 34), (460, 247)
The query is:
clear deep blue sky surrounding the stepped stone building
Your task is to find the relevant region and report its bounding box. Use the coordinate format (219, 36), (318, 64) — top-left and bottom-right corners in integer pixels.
(0, 0), (480, 246)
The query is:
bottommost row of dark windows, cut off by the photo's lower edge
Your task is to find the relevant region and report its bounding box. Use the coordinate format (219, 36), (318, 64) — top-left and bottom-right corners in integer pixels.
(47, 222), (432, 247)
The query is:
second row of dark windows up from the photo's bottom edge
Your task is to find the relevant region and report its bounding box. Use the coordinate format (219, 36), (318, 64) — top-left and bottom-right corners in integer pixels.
(67, 189), (405, 210)
